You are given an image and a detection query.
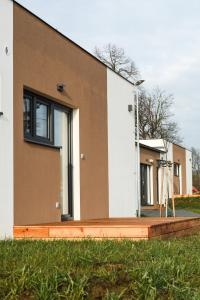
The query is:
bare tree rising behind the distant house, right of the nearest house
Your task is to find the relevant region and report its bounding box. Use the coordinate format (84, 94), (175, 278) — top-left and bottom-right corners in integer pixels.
(139, 88), (182, 144)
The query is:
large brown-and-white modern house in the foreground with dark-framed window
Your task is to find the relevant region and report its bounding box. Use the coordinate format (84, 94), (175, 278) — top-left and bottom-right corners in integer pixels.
(0, 0), (137, 237)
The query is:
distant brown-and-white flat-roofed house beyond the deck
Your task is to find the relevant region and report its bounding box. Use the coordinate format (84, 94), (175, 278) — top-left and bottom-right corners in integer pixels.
(140, 139), (192, 206)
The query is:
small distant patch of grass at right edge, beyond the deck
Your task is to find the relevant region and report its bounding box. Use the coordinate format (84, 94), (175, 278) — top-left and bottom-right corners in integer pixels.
(175, 197), (200, 214)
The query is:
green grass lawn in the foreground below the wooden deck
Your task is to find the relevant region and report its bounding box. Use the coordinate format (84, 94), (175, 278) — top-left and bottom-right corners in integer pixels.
(0, 235), (200, 300)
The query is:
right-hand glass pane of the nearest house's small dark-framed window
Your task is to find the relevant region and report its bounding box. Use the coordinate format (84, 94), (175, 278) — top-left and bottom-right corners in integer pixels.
(36, 101), (49, 138)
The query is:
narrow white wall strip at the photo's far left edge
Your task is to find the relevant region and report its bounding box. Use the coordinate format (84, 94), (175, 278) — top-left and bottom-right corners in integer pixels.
(0, 0), (13, 239)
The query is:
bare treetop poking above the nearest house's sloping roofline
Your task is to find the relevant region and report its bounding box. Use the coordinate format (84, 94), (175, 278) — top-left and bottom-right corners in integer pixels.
(94, 44), (139, 82)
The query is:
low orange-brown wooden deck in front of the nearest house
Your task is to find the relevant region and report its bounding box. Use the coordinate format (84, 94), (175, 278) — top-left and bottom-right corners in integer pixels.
(14, 218), (200, 240)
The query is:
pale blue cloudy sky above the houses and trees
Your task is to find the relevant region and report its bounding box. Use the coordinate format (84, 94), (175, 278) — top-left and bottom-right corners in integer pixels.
(18, 0), (200, 148)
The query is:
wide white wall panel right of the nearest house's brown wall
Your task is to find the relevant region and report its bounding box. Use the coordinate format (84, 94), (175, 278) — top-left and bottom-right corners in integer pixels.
(107, 69), (137, 217)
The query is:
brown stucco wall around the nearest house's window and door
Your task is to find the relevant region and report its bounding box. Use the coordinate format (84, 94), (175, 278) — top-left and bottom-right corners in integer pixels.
(14, 3), (108, 225)
